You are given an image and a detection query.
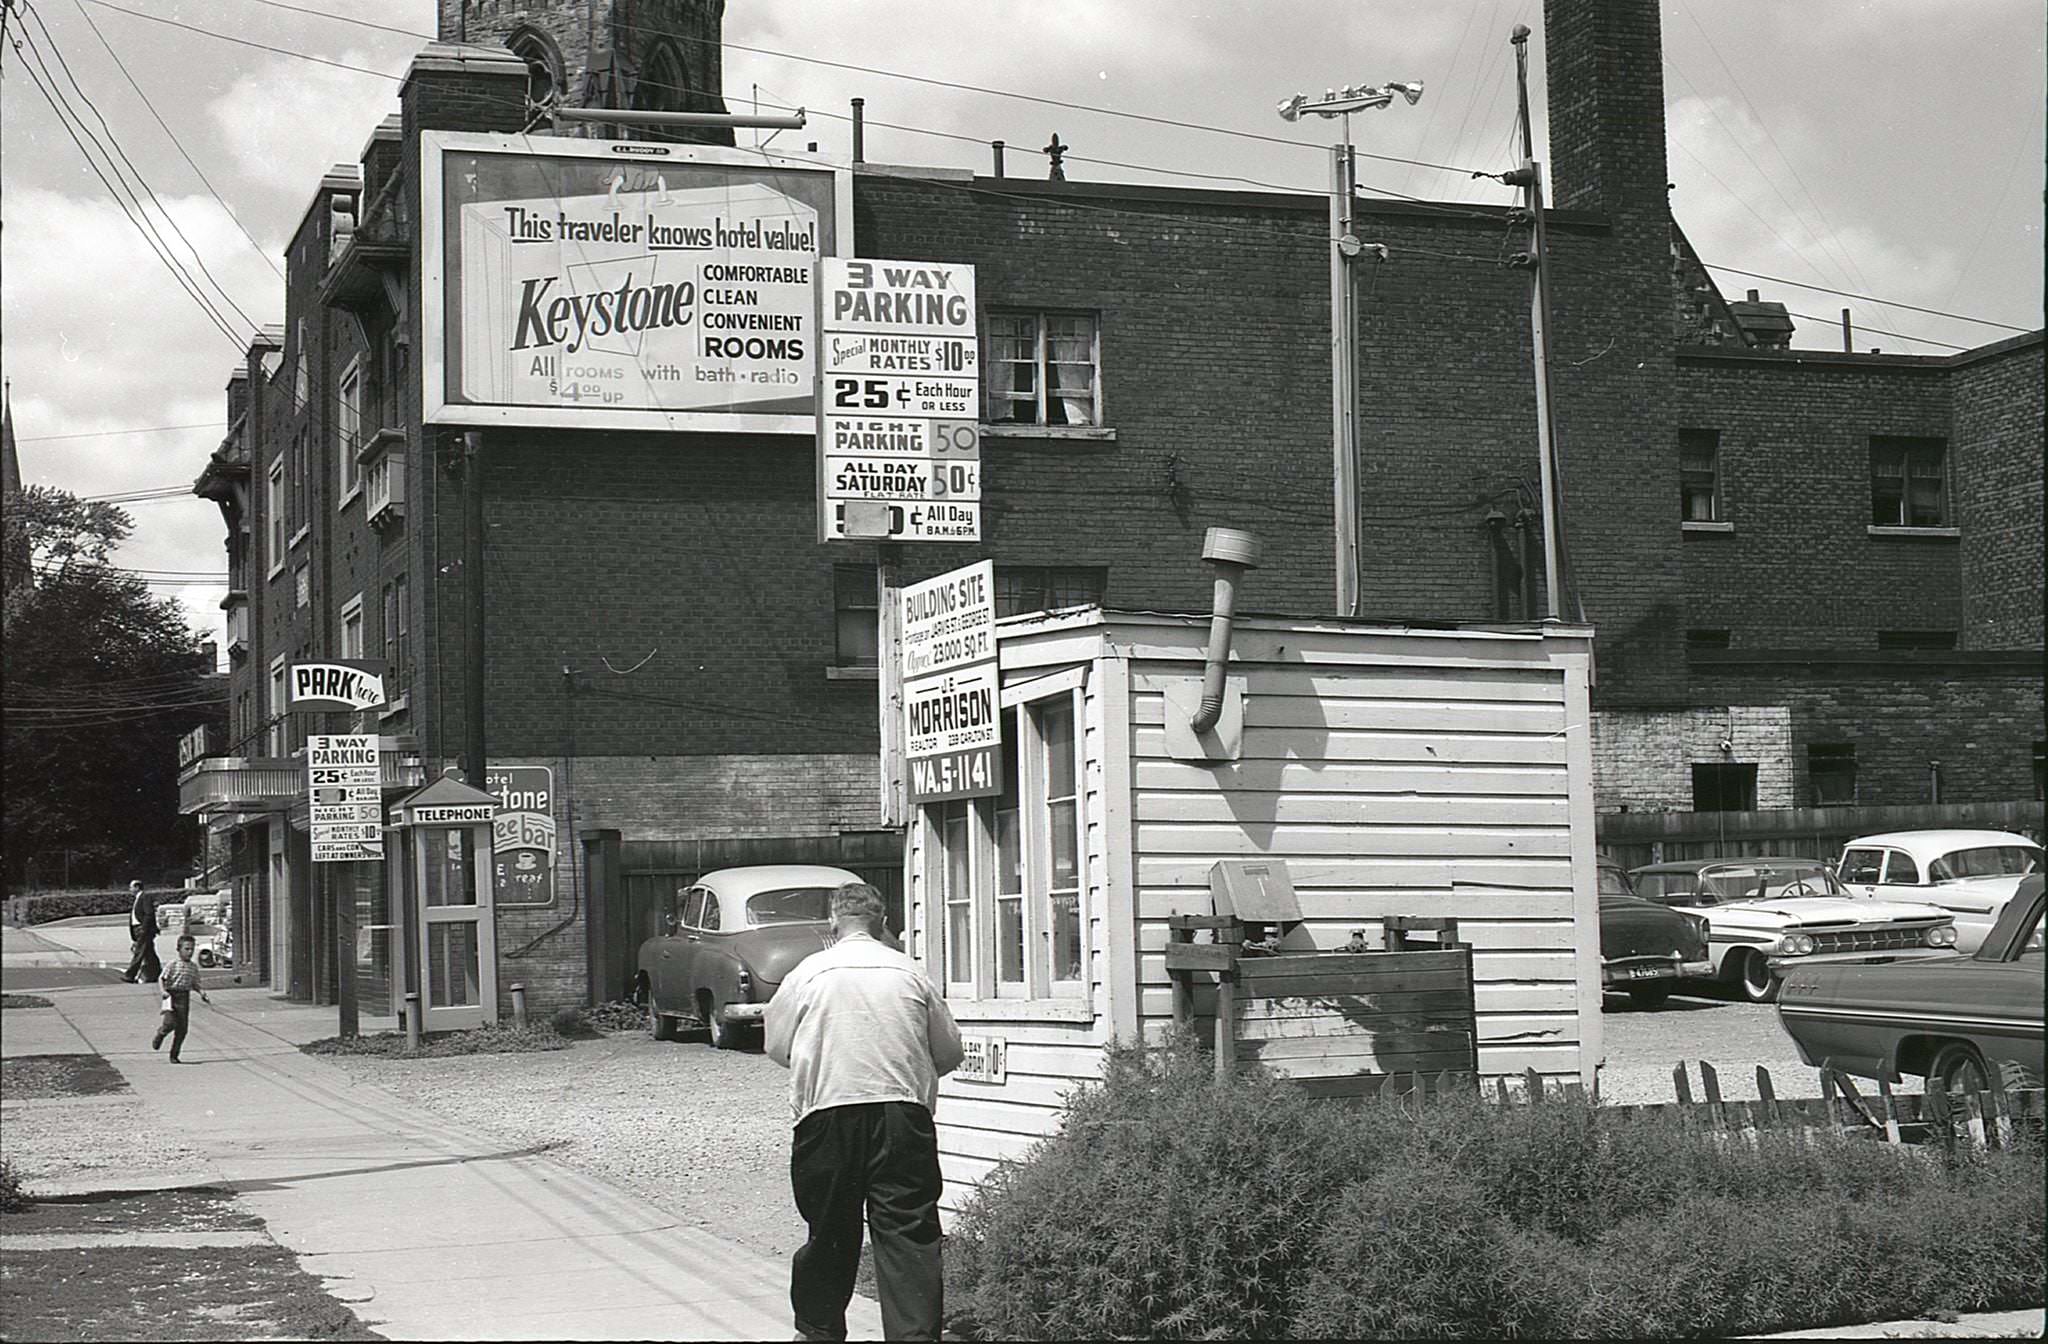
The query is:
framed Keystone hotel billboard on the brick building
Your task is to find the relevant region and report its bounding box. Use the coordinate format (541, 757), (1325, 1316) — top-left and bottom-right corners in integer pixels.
(420, 131), (852, 434)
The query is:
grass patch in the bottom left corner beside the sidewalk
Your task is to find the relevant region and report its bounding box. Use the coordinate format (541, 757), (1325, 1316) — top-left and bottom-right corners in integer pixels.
(0, 1246), (383, 1342)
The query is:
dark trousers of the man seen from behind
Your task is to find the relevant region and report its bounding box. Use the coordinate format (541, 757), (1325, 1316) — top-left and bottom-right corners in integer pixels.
(788, 1102), (942, 1340)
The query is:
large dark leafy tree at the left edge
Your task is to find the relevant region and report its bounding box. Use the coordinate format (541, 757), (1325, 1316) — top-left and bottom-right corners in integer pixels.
(0, 486), (227, 885)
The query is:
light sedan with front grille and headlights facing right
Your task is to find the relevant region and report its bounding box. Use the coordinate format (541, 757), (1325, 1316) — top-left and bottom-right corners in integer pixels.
(1628, 856), (1956, 1004)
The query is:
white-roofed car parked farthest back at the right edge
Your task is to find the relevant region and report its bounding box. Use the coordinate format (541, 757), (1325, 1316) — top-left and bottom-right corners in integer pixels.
(1835, 830), (2042, 953)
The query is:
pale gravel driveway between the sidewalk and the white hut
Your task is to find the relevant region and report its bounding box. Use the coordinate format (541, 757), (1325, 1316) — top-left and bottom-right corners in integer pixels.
(324, 1033), (803, 1256)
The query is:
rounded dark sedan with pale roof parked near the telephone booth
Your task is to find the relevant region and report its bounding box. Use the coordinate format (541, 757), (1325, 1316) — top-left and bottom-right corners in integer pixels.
(635, 863), (860, 1049)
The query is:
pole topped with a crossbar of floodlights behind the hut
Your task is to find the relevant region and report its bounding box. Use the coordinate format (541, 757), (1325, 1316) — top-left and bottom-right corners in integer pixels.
(1280, 80), (1421, 617)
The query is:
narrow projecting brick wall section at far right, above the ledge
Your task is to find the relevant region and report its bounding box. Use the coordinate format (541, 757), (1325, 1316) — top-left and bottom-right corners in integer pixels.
(1950, 334), (2044, 649)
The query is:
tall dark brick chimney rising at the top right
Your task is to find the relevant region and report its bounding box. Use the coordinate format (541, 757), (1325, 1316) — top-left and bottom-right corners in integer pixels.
(1542, 0), (1669, 223)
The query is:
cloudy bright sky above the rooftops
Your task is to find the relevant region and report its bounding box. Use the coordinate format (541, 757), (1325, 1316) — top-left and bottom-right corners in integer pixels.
(0, 0), (2048, 651)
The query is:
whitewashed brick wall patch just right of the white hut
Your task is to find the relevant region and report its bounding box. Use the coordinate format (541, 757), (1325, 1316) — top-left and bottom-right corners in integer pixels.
(1593, 705), (1794, 811)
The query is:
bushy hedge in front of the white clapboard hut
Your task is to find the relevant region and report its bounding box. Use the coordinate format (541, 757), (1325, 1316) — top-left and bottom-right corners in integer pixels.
(946, 1043), (2048, 1340)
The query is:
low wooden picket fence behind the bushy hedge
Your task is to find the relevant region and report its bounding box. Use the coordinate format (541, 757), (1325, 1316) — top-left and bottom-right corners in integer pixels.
(1318, 1059), (2048, 1151)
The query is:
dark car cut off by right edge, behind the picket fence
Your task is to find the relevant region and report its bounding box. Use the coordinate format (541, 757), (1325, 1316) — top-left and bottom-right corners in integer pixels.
(1778, 873), (2044, 1090)
